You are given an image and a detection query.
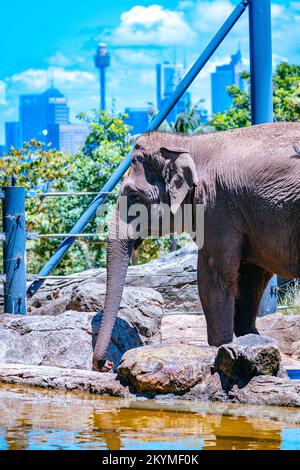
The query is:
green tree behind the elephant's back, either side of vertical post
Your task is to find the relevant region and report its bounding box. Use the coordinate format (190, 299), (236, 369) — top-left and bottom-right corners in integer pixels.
(210, 62), (300, 130)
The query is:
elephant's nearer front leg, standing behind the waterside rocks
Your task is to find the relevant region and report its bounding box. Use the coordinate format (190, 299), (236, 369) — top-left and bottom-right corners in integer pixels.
(198, 250), (238, 346)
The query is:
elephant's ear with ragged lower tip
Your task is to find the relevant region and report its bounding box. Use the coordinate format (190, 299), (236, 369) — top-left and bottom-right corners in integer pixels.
(160, 147), (198, 214)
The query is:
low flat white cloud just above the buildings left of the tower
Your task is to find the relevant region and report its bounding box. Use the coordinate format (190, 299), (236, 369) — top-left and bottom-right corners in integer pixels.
(9, 67), (96, 91)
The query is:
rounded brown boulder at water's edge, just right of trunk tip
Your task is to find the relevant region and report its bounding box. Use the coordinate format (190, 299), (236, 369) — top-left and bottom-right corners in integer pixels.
(118, 344), (217, 395)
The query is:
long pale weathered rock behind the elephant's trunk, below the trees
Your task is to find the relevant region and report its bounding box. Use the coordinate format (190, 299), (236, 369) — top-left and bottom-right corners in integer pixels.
(28, 243), (203, 315)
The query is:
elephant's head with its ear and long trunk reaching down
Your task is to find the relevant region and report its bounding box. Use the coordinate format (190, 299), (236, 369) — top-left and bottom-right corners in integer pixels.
(93, 133), (198, 370)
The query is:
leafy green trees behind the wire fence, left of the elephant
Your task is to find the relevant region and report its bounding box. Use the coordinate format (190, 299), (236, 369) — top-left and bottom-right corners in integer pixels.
(0, 111), (129, 274)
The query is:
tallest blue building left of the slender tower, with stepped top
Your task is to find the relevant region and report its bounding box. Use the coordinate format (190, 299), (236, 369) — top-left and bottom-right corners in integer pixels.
(19, 87), (70, 142)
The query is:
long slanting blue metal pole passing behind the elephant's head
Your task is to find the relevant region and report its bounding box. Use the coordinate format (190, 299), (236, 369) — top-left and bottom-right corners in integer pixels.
(27, 0), (248, 296)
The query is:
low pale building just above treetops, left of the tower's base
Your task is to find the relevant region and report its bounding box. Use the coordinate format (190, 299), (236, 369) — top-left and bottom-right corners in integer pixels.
(47, 124), (90, 154)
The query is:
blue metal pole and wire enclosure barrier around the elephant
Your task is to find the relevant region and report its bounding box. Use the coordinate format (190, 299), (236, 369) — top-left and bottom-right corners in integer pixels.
(1, 0), (277, 314)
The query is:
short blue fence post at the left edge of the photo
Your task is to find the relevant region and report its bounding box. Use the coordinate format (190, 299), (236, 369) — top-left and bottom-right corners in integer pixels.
(3, 186), (26, 315)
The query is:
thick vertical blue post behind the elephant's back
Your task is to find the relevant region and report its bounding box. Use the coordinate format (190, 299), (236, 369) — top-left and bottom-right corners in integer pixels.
(249, 0), (277, 316)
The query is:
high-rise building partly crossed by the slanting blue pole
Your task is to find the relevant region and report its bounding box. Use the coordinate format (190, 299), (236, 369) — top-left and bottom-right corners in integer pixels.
(156, 62), (190, 122)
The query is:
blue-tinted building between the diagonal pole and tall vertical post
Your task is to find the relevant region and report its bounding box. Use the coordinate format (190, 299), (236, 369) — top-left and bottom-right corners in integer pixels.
(211, 50), (244, 113)
